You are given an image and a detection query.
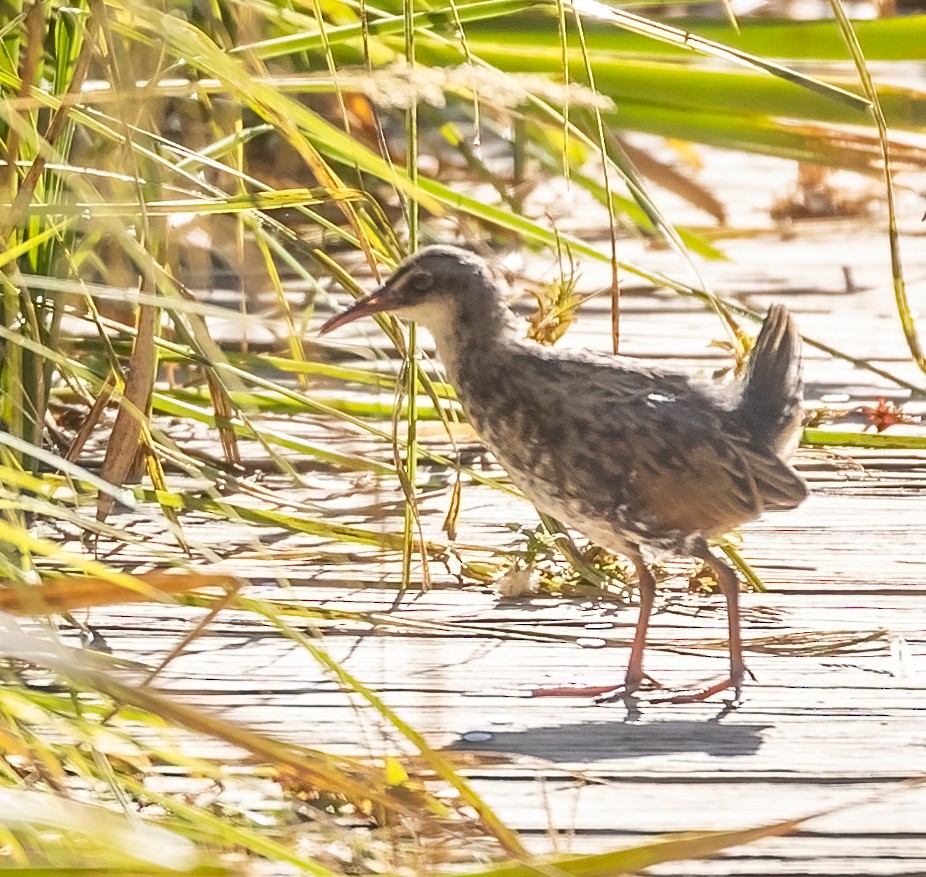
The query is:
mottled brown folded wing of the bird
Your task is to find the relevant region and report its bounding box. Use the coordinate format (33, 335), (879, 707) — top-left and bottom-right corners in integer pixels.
(512, 358), (806, 535)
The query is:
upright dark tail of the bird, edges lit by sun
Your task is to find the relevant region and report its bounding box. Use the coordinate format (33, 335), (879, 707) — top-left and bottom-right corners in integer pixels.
(737, 305), (803, 457)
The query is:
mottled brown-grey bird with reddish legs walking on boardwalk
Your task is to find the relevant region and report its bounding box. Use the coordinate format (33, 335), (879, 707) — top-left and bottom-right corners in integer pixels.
(320, 245), (808, 703)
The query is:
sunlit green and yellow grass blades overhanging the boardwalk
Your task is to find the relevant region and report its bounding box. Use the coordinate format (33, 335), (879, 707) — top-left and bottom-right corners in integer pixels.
(0, 0), (926, 877)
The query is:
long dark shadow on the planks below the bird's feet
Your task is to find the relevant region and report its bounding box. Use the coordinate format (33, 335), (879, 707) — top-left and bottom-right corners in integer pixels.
(449, 721), (770, 763)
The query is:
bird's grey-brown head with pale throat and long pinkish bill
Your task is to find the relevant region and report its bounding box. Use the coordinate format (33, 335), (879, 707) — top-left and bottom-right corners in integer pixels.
(320, 246), (501, 334)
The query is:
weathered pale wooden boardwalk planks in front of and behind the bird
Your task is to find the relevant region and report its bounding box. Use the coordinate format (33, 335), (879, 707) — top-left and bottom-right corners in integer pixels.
(59, 147), (926, 877)
